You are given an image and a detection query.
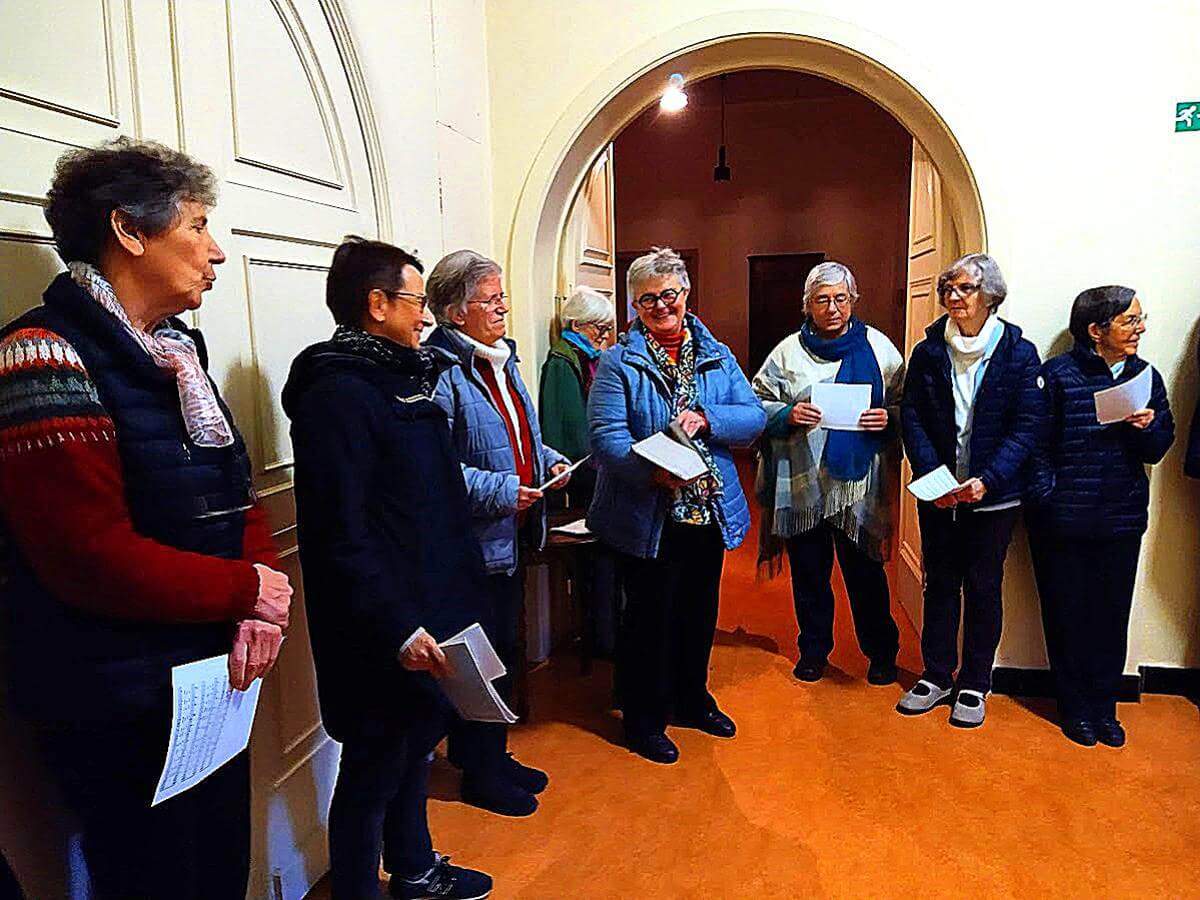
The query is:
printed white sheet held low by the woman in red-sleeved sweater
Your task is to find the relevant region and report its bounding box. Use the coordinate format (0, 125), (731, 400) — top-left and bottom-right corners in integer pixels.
(150, 654), (263, 806)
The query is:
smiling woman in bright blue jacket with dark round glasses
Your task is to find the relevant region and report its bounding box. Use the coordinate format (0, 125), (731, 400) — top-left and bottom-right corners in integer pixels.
(588, 250), (766, 763)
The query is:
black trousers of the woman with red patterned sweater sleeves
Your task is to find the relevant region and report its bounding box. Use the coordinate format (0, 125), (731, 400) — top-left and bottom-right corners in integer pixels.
(38, 710), (250, 900)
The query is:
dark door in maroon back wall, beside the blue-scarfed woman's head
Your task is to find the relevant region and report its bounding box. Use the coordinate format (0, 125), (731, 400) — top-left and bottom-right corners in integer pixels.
(746, 253), (824, 377)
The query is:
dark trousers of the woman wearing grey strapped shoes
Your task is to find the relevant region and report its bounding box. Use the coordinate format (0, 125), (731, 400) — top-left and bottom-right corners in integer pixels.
(918, 503), (1021, 694)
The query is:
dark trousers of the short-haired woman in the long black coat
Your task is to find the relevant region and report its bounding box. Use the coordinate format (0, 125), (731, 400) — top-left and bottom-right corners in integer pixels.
(329, 697), (452, 900)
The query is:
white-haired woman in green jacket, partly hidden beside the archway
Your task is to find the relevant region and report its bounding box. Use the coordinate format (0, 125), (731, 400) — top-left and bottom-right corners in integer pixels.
(538, 288), (617, 509)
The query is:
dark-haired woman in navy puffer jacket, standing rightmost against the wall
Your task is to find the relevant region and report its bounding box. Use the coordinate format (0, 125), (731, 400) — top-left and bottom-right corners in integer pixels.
(1030, 286), (1175, 746)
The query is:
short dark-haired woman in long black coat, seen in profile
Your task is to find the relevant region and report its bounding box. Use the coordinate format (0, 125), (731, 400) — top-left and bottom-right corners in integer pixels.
(283, 239), (492, 900)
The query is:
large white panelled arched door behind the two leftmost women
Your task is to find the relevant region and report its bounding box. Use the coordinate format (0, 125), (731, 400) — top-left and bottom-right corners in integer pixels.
(0, 0), (378, 900)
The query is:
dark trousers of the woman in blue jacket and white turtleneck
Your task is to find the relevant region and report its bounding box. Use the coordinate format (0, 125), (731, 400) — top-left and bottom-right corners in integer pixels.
(446, 571), (526, 778)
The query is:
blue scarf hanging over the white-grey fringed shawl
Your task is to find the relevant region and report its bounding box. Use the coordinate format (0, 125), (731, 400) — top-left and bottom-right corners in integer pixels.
(800, 319), (883, 481)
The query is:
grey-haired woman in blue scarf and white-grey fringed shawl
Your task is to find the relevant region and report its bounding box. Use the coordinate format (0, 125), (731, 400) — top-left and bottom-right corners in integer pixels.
(754, 262), (904, 684)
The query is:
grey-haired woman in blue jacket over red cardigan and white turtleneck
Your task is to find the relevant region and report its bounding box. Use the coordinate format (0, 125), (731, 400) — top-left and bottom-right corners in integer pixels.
(425, 250), (570, 816)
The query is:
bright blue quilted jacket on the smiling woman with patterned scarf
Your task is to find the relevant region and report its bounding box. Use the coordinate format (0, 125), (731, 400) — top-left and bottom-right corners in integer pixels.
(588, 313), (767, 559)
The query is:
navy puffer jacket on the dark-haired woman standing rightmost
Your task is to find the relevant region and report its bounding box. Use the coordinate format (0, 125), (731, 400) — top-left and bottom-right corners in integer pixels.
(1030, 344), (1175, 539)
